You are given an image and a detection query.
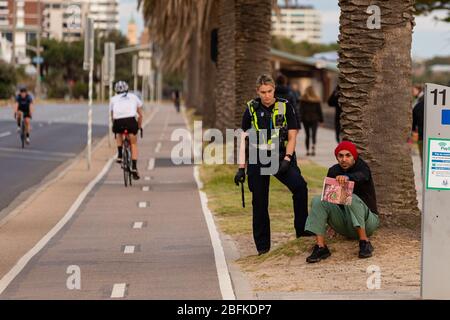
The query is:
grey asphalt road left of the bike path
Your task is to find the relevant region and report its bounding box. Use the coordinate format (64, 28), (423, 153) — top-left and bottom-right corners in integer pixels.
(0, 104), (108, 219)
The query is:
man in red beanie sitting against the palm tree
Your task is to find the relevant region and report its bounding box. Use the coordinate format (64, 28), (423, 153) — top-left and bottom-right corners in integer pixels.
(305, 141), (379, 263)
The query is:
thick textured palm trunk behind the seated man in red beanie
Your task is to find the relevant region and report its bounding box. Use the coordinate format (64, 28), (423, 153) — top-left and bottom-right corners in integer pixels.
(339, 0), (419, 220)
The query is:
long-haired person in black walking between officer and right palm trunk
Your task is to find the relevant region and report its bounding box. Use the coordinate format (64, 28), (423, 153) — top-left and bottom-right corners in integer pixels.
(300, 86), (323, 156)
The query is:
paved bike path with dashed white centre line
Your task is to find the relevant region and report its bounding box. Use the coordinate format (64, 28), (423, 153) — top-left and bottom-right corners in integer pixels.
(0, 105), (222, 299)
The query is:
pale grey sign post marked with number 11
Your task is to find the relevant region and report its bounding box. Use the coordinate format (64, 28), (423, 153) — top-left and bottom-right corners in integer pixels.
(421, 83), (450, 299)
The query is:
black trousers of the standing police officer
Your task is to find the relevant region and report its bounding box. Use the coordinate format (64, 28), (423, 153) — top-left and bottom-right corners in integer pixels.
(248, 157), (308, 251)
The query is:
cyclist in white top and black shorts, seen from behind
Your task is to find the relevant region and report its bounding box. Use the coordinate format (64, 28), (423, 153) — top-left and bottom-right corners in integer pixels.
(109, 81), (143, 180)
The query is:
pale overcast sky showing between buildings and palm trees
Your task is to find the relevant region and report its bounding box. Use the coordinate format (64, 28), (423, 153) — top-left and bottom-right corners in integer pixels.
(119, 0), (450, 58)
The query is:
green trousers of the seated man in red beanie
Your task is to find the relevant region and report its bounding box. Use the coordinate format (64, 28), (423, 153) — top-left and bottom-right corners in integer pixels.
(305, 194), (380, 239)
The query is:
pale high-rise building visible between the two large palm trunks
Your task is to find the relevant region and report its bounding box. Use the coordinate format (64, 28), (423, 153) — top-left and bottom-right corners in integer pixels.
(272, 5), (322, 43)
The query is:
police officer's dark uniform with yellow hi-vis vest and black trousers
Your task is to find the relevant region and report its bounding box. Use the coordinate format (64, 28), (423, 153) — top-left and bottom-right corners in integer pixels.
(242, 98), (308, 252)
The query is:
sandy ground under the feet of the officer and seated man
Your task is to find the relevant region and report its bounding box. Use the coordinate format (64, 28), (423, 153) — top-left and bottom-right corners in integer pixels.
(234, 222), (420, 292)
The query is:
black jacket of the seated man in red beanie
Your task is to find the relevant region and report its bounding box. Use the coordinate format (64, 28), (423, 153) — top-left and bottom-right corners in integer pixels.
(327, 158), (378, 214)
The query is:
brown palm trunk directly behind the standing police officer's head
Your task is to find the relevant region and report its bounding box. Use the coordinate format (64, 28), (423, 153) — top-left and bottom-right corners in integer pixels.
(216, 0), (272, 131)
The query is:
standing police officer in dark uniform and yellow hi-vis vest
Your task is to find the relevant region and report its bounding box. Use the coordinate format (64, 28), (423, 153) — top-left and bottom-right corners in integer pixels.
(234, 74), (311, 255)
